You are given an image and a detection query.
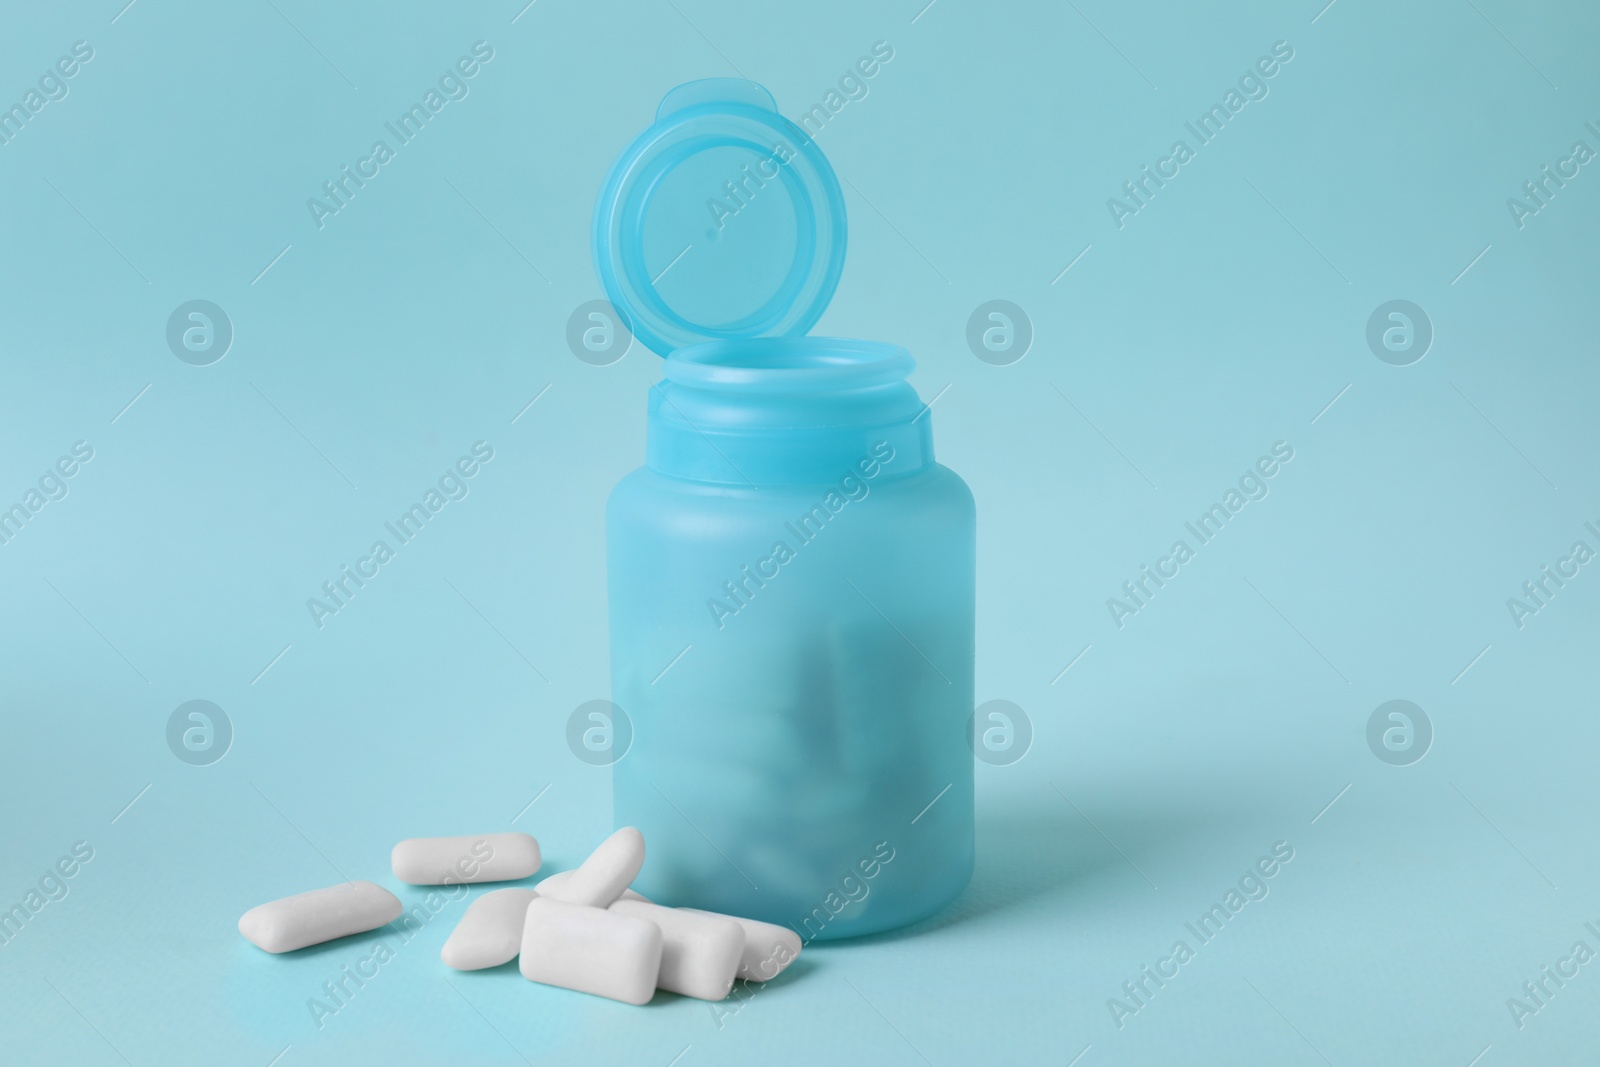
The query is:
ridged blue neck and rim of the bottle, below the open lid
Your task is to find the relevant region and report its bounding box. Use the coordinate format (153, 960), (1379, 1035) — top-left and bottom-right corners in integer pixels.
(645, 338), (933, 486)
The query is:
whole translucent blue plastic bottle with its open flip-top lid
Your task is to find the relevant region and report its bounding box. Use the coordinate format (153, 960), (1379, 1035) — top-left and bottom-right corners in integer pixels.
(595, 80), (976, 941)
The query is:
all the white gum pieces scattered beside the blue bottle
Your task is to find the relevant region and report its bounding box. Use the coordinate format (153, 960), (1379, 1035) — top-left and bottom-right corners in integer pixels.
(238, 827), (800, 1005)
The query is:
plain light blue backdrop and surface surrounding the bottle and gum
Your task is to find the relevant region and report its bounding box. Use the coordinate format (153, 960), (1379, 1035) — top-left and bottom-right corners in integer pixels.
(0, 0), (1600, 1067)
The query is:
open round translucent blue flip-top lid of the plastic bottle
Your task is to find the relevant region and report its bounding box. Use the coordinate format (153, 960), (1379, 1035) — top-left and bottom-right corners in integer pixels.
(594, 78), (845, 355)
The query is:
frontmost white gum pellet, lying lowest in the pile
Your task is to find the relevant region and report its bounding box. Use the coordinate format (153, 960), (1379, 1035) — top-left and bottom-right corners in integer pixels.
(518, 896), (662, 1005)
